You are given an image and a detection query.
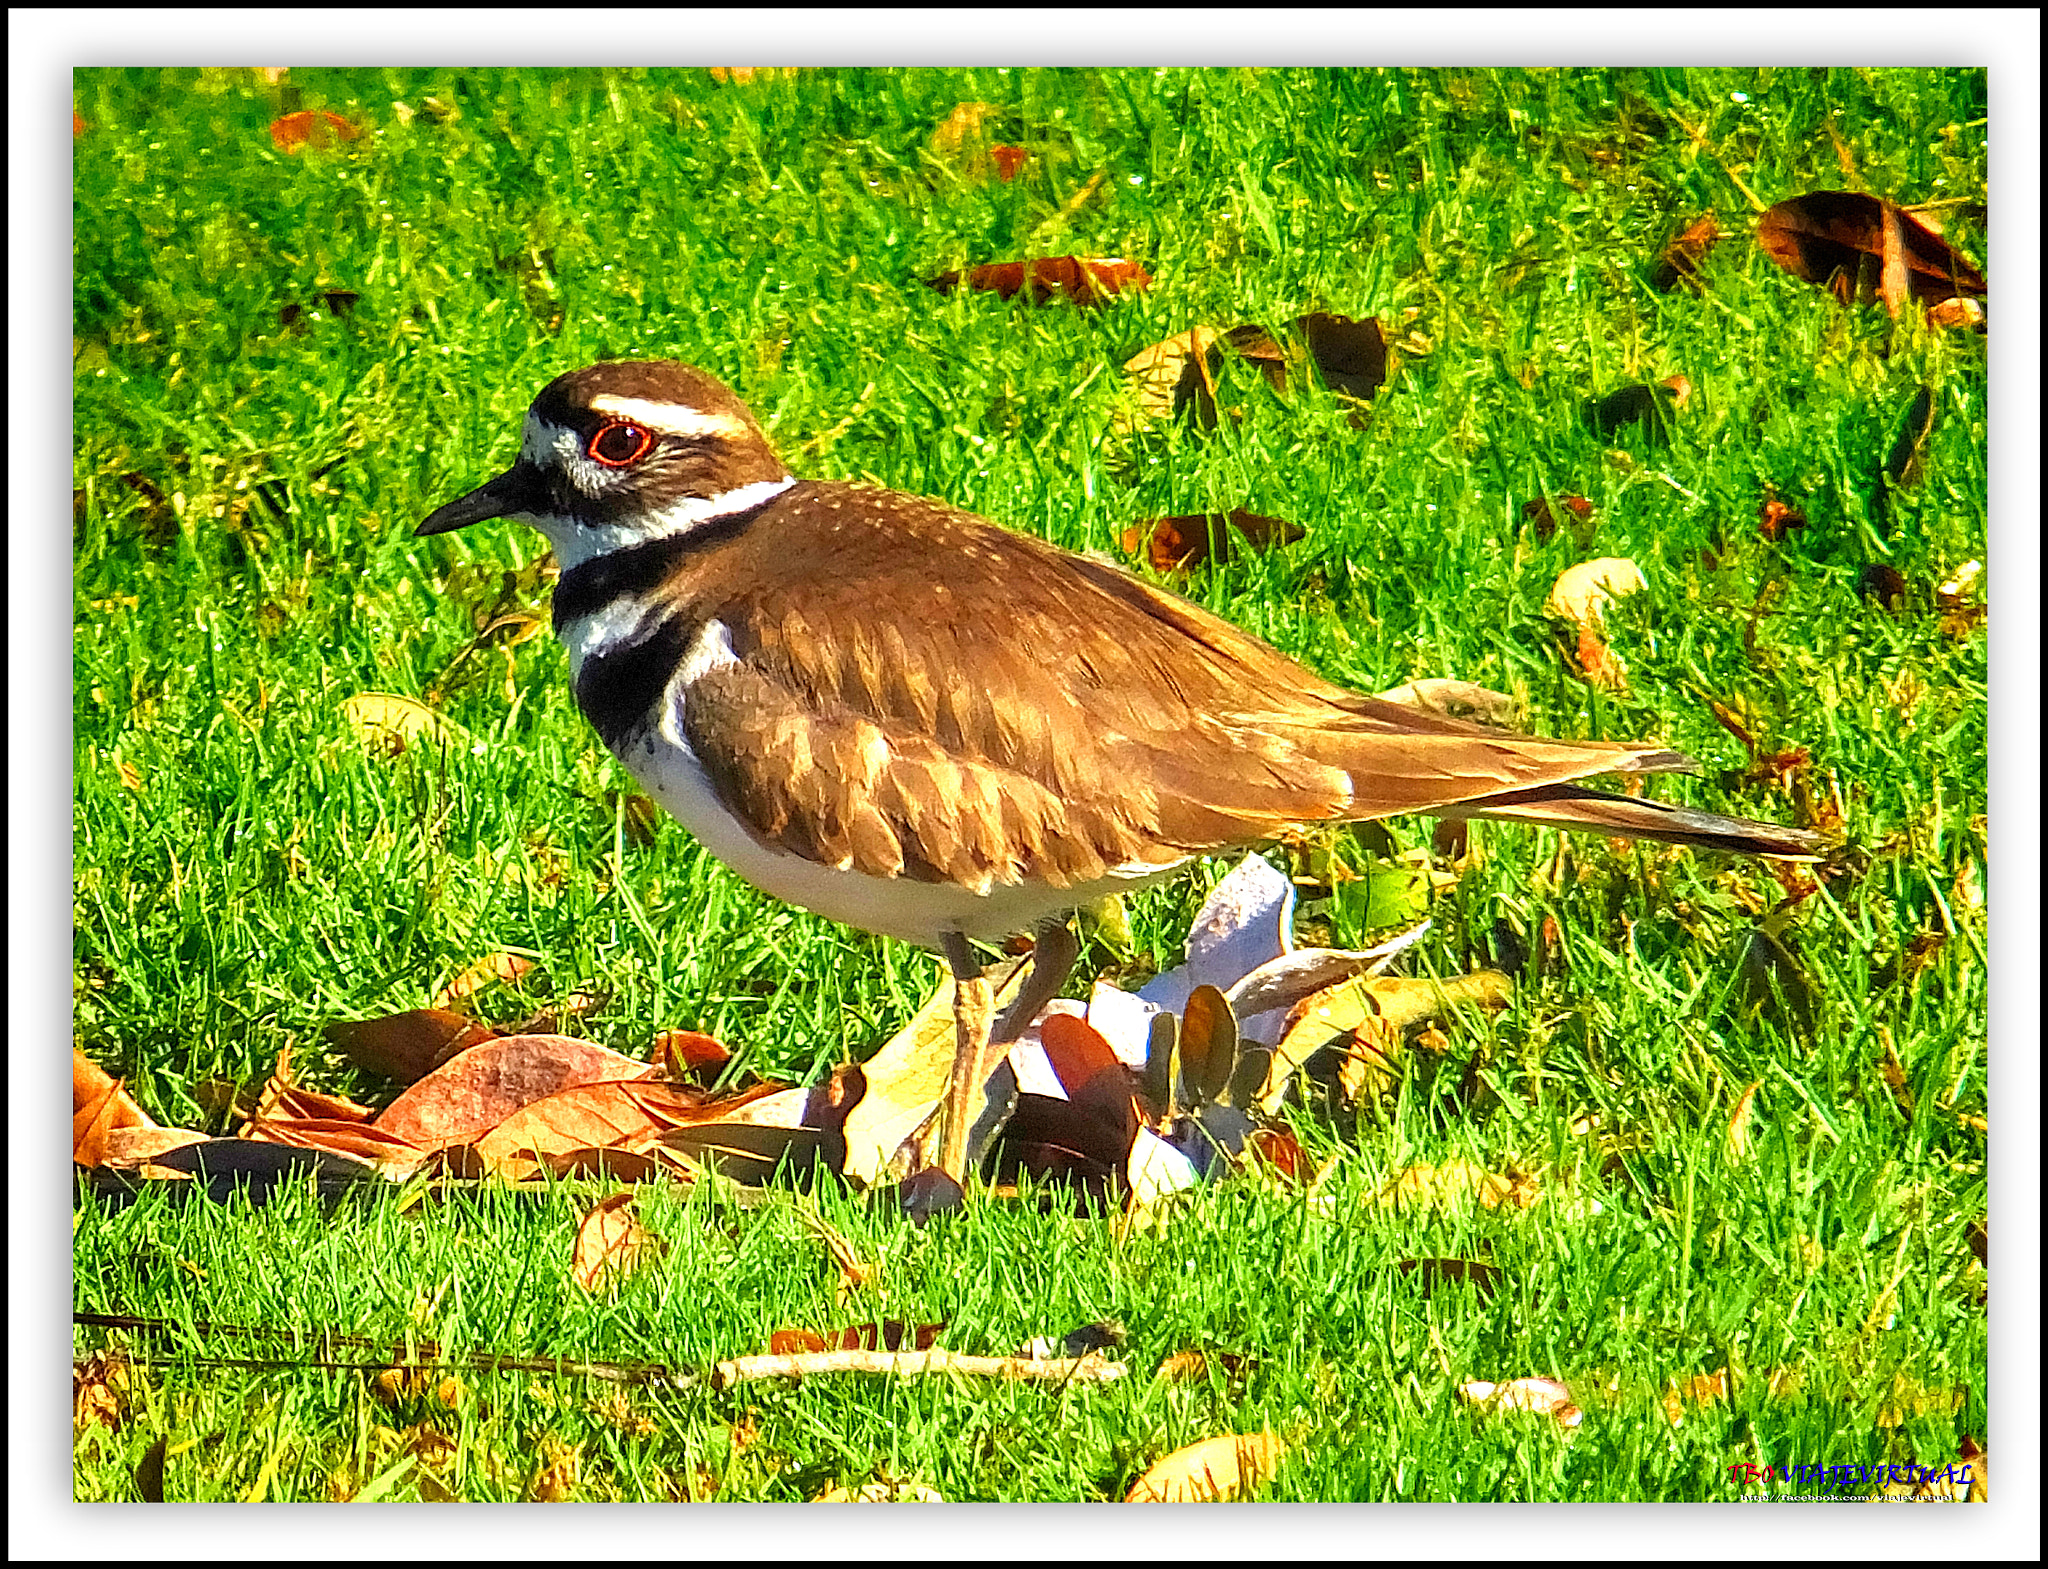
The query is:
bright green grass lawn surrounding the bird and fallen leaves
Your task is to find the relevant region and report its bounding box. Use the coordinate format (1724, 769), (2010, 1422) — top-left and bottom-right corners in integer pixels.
(74, 70), (1997, 1499)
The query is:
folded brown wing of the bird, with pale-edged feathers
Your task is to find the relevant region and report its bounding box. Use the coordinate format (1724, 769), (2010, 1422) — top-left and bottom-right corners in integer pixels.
(663, 485), (1686, 887)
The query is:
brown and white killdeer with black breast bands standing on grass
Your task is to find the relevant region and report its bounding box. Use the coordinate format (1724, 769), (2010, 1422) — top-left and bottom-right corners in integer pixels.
(418, 361), (1815, 1180)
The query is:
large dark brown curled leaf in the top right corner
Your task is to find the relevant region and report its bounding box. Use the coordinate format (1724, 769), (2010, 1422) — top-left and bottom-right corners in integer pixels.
(1757, 190), (1987, 315)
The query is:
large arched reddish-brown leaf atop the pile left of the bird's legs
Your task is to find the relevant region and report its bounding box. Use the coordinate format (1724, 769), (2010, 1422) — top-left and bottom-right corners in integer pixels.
(377, 1034), (655, 1149)
